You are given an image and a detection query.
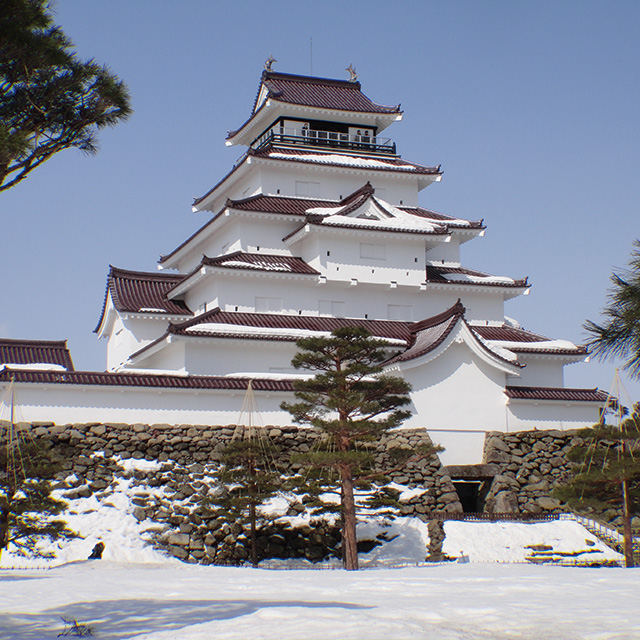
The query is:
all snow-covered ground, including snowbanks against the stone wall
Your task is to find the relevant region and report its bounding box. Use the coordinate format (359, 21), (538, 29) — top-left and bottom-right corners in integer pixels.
(0, 458), (640, 640)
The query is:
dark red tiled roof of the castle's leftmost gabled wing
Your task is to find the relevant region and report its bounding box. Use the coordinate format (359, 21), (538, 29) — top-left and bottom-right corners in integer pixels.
(94, 266), (191, 332)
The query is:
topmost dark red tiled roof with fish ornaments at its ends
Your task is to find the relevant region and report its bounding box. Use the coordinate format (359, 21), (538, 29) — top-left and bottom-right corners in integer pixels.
(254, 71), (400, 113)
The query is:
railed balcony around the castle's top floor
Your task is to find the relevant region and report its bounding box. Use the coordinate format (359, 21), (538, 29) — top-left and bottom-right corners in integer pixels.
(254, 126), (396, 155)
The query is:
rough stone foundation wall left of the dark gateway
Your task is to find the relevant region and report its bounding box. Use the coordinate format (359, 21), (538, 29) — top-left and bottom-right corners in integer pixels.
(2, 423), (462, 564)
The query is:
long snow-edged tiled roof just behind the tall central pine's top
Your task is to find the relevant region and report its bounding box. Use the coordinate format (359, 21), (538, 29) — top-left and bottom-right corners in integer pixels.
(169, 308), (412, 340)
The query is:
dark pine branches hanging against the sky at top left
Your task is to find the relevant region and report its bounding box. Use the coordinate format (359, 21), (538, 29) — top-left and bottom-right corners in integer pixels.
(0, 0), (131, 191)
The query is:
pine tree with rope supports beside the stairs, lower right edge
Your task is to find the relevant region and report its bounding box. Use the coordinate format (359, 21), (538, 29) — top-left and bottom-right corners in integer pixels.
(554, 403), (640, 567)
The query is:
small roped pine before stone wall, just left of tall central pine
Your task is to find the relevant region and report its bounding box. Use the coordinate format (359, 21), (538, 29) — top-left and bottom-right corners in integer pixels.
(210, 427), (282, 567)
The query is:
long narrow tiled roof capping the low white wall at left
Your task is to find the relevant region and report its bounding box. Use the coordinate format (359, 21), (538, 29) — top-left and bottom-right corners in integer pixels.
(0, 370), (293, 391)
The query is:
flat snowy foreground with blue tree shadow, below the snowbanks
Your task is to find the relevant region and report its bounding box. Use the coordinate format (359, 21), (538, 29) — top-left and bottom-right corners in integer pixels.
(0, 560), (640, 640)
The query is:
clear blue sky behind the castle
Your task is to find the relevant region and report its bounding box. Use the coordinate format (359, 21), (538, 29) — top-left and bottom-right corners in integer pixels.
(0, 0), (640, 400)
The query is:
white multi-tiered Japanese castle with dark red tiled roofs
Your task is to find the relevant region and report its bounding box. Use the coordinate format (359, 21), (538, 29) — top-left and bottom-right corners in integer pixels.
(0, 66), (606, 464)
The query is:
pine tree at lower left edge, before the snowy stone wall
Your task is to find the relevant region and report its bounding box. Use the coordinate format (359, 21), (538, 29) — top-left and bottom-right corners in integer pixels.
(0, 437), (75, 557)
